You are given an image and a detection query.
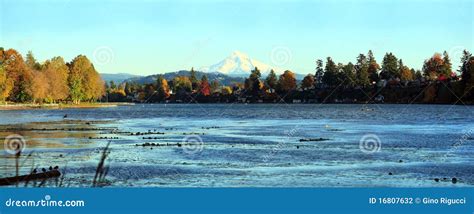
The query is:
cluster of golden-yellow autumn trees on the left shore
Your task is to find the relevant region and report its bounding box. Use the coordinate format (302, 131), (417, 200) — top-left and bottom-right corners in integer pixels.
(0, 48), (105, 104)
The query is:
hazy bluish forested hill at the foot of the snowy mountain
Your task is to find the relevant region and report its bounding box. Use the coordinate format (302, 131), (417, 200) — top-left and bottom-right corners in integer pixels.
(125, 70), (245, 85)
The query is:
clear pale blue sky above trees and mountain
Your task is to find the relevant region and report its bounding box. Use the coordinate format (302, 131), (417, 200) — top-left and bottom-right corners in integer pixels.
(0, 0), (474, 75)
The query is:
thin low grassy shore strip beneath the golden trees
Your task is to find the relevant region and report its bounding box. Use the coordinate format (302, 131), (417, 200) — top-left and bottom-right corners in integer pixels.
(0, 102), (135, 111)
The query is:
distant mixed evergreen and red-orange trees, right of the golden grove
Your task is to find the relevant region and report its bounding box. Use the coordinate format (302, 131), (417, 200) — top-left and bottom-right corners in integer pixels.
(107, 50), (474, 103)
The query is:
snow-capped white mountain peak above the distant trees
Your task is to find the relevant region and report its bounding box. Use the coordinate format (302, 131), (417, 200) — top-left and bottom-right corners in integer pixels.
(201, 51), (283, 77)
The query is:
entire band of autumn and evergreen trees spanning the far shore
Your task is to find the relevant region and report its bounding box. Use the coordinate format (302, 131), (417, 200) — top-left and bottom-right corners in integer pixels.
(0, 48), (474, 104)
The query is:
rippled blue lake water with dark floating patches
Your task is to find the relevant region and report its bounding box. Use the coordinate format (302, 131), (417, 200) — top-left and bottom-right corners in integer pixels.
(0, 104), (474, 187)
